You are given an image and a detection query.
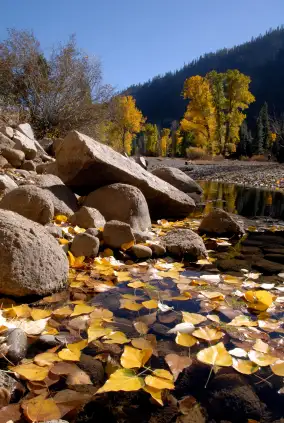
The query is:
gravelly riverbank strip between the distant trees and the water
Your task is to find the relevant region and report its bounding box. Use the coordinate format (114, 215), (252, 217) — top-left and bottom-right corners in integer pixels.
(147, 157), (284, 190)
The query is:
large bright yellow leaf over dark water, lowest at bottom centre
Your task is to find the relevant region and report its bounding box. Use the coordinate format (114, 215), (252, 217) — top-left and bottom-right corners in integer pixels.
(97, 369), (144, 394)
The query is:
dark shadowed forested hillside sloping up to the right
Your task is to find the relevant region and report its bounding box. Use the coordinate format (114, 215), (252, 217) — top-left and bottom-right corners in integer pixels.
(126, 26), (284, 127)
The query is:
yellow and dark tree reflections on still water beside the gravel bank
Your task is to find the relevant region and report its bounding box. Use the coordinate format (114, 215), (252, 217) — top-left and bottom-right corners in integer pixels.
(199, 181), (284, 219)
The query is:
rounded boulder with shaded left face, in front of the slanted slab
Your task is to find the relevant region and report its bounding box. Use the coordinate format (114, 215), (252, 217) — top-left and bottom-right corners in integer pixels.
(84, 184), (151, 231)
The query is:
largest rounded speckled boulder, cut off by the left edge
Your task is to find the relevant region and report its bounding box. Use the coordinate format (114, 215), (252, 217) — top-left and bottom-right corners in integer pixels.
(0, 210), (69, 296)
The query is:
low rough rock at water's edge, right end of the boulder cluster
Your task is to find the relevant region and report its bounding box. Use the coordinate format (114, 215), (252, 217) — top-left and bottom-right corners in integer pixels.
(162, 229), (207, 261)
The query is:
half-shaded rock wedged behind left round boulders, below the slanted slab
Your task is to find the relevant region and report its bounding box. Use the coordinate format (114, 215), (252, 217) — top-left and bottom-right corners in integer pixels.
(33, 175), (78, 217)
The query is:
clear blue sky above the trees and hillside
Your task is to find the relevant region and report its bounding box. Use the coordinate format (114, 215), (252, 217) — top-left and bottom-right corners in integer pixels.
(0, 0), (284, 89)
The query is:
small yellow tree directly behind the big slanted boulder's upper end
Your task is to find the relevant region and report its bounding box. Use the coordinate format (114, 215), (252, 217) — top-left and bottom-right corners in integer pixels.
(109, 96), (146, 154)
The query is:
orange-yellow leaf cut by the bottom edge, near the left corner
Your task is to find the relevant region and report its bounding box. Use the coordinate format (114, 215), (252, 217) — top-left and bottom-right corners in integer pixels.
(22, 395), (61, 422)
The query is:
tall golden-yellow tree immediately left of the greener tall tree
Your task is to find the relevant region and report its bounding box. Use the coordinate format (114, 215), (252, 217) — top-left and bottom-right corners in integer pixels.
(181, 75), (216, 154)
